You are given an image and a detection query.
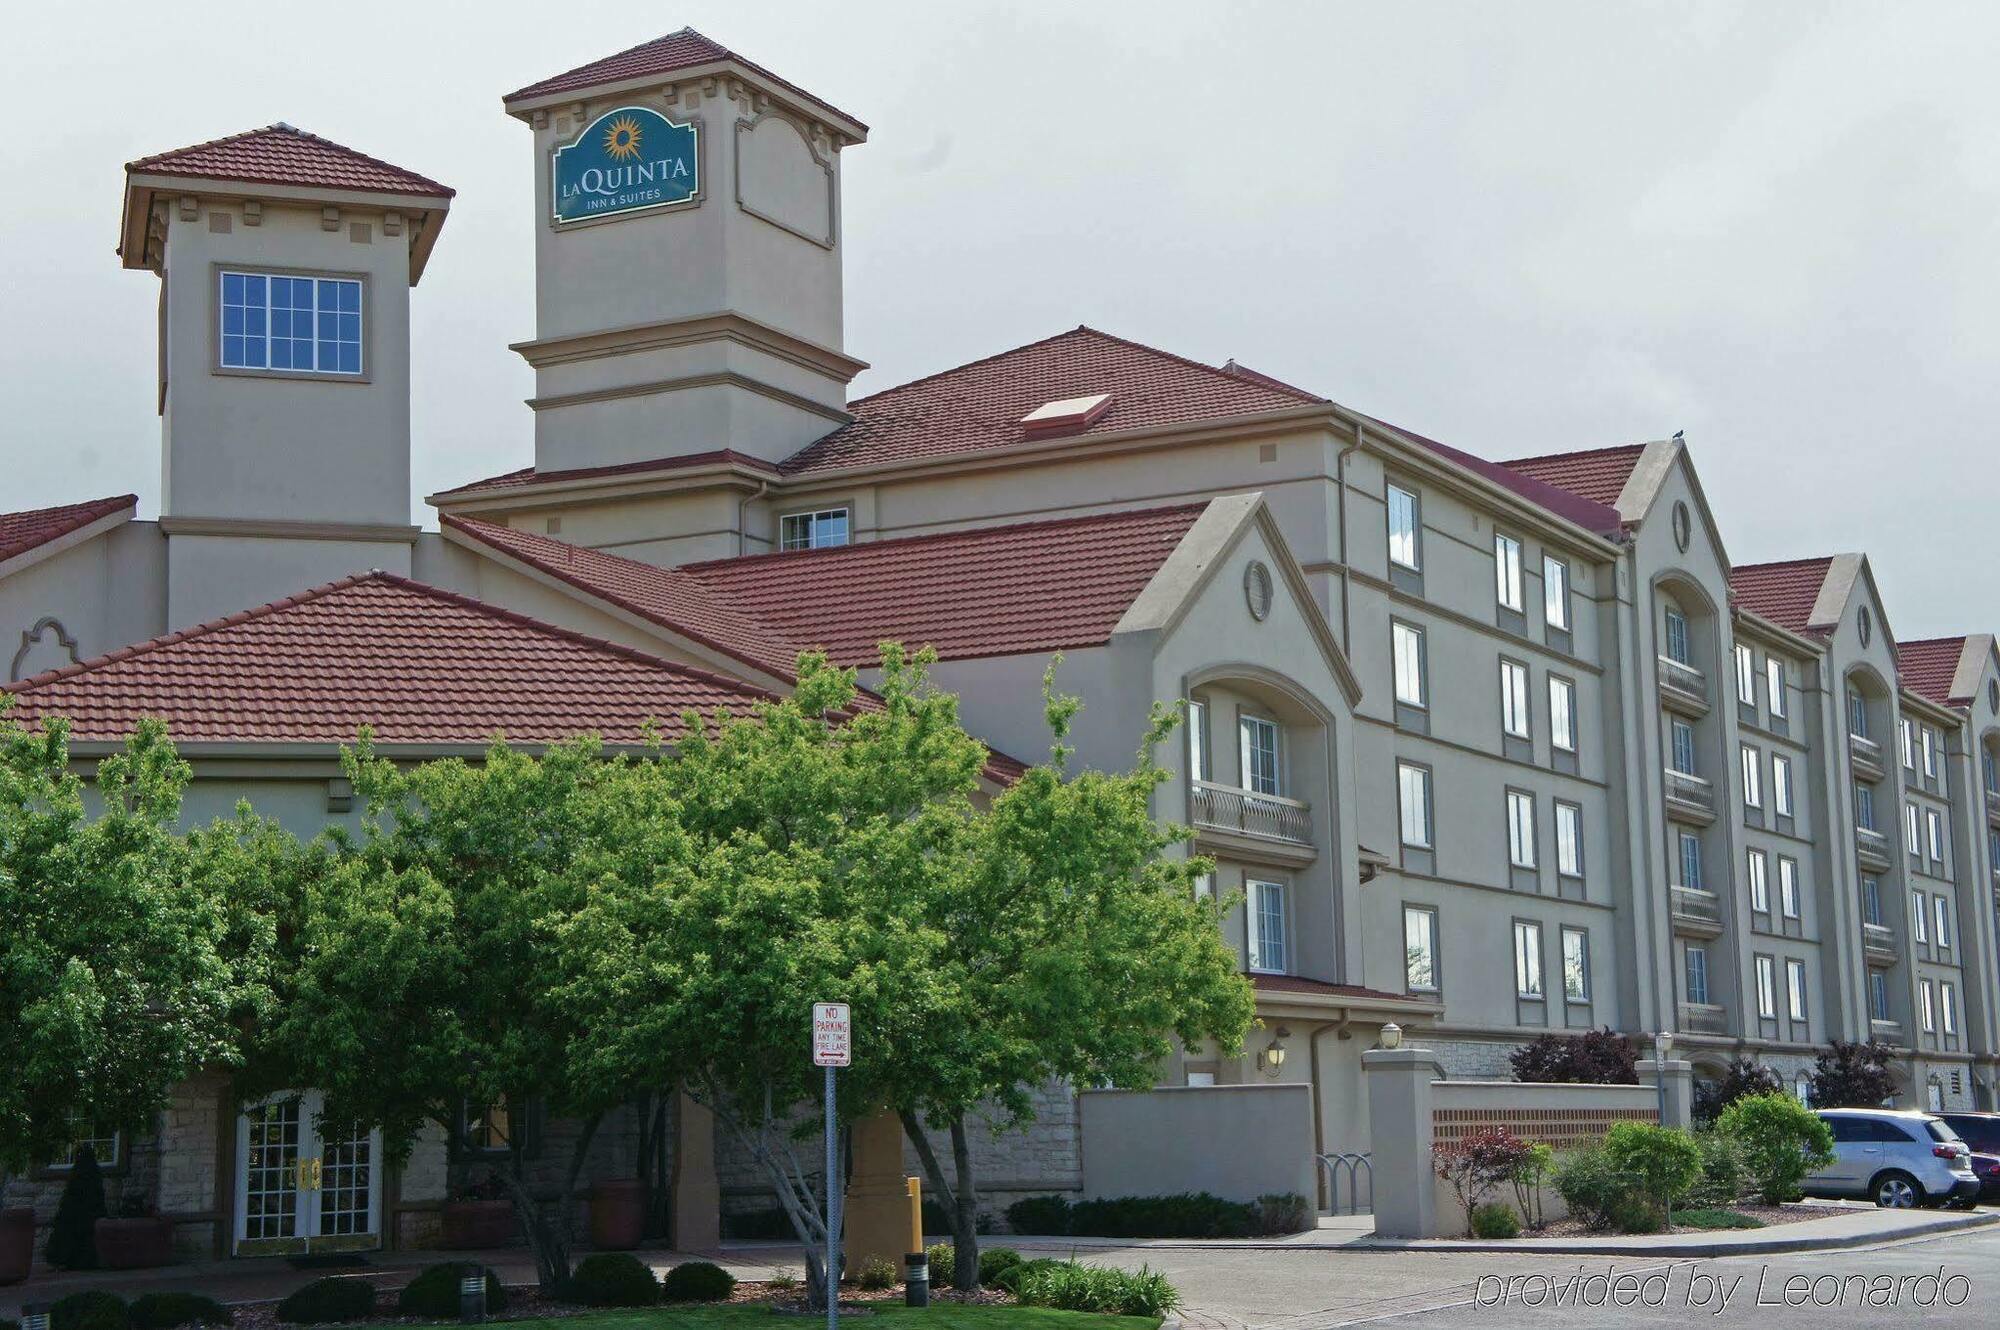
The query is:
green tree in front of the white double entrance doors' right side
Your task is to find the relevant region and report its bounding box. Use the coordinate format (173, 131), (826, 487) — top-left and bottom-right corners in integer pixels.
(246, 734), (678, 1288)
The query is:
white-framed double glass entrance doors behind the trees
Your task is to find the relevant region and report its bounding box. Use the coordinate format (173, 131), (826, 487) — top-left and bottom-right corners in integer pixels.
(236, 1090), (382, 1256)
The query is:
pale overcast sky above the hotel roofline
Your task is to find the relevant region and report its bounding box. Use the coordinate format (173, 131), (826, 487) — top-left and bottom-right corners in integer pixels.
(0, 0), (2000, 638)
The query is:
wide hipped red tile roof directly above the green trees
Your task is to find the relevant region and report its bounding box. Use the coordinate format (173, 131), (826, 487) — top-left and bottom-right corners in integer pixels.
(1, 572), (770, 744)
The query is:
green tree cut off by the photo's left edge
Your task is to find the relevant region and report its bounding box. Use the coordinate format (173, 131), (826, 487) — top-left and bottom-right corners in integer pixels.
(0, 712), (268, 1184)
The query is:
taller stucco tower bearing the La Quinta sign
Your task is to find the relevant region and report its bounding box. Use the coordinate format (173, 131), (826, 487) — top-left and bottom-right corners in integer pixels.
(504, 28), (868, 472)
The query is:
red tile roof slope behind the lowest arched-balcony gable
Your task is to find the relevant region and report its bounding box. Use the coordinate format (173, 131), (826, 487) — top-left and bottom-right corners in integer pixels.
(682, 504), (1204, 666)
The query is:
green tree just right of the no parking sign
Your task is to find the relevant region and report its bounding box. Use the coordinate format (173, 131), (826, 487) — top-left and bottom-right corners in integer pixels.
(886, 664), (1254, 1290)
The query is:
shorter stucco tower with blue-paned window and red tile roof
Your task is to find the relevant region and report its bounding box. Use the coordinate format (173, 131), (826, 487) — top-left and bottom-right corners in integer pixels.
(118, 124), (452, 628)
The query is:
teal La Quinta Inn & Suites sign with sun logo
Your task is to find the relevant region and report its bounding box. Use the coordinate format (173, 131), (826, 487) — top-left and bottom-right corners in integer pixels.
(550, 106), (702, 226)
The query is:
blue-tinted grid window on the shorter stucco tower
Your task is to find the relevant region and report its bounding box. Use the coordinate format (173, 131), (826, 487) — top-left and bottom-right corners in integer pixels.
(220, 272), (362, 374)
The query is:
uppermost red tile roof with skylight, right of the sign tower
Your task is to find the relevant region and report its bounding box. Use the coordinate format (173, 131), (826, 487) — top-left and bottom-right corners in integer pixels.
(784, 328), (1324, 476)
